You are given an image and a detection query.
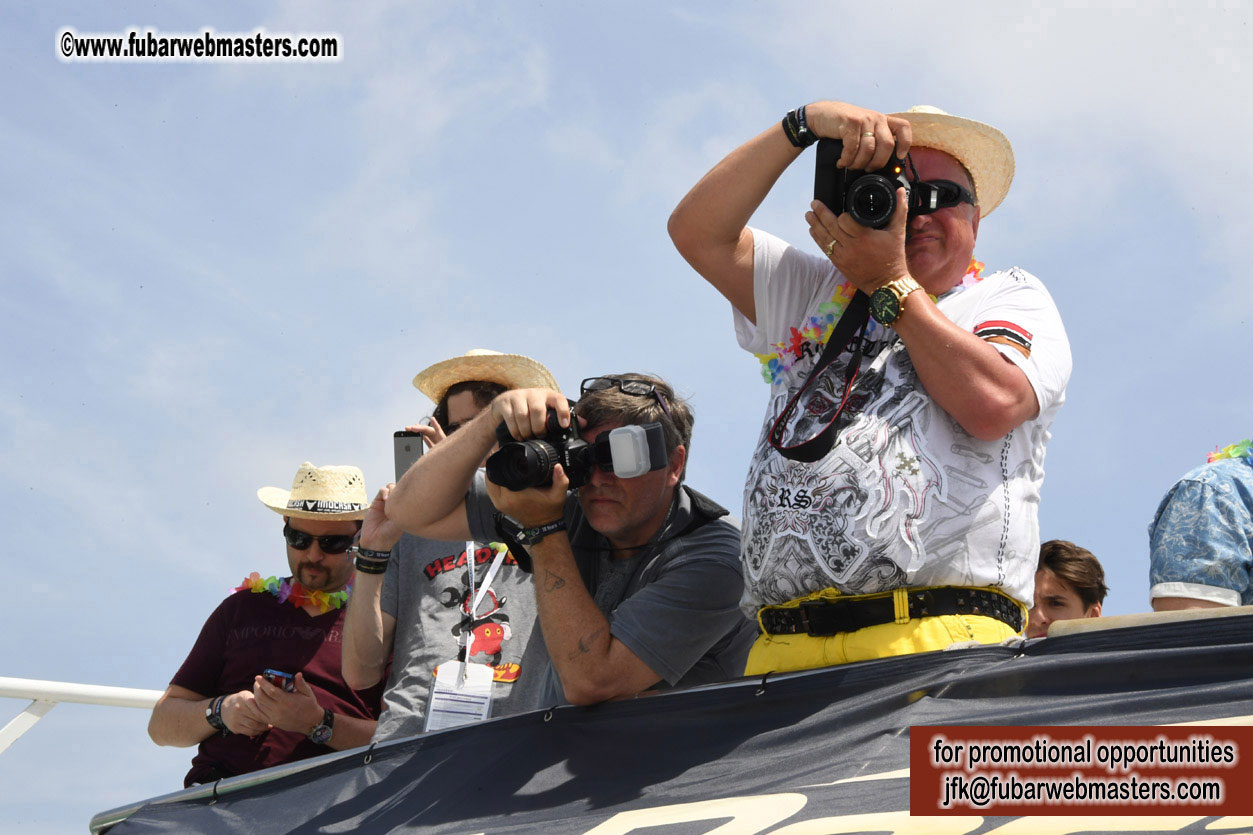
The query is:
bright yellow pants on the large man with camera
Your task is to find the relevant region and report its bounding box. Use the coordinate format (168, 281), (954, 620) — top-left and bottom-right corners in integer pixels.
(744, 588), (1026, 676)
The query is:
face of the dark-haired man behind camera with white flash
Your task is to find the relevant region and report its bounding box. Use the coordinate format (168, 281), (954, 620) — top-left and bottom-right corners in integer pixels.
(579, 421), (687, 548)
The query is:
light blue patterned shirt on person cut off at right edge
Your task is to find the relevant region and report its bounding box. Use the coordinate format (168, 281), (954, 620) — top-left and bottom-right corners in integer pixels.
(1149, 458), (1253, 606)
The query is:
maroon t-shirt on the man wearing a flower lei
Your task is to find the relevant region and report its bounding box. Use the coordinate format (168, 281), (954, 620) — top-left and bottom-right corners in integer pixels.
(170, 581), (387, 786)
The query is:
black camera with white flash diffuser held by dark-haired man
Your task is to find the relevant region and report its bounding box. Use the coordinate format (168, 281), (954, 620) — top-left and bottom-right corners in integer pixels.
(487, 404), (669, 491)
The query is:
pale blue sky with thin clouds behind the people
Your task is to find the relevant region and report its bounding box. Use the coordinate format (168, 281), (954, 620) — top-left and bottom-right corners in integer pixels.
(0, 1), (1253, 831)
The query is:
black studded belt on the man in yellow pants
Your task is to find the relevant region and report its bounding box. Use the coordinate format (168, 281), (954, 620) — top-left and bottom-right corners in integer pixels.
(761, 586), (1022, 637)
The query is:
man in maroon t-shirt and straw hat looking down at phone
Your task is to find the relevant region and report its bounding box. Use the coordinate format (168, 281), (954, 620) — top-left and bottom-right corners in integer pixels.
(148, 463), (382, 786)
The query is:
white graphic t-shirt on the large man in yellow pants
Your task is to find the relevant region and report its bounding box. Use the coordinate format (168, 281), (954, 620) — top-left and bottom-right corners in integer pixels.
(734, 229), (1070, 611)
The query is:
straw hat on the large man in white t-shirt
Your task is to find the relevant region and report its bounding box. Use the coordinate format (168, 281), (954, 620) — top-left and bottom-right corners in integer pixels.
(888, 104), (1014, 217)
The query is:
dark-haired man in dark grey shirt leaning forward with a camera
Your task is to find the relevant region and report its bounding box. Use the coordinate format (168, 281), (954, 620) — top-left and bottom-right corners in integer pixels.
(387, 374), (752, 707)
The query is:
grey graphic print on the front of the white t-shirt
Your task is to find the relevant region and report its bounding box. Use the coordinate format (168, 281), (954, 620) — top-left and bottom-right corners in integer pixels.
(743, 341), (1004, 603)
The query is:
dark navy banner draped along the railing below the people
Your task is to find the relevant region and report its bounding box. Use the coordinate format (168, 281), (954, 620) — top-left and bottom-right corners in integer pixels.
(110, 616), (1253, 835)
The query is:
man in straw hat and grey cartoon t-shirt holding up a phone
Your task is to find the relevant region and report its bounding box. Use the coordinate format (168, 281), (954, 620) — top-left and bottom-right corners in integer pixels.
(343, 349), (558, 740)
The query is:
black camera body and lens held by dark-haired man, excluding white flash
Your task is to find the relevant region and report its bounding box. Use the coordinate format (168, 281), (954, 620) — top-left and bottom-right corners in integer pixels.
(487, 404), (596, 491)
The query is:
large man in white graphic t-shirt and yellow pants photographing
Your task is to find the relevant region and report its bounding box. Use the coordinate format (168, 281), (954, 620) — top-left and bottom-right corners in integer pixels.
(669, 102), (1070, 673)
